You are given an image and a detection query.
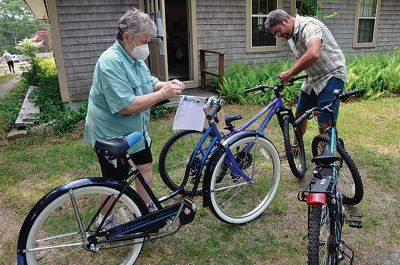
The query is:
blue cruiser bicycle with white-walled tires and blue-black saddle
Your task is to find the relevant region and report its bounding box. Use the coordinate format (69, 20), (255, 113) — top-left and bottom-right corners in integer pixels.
(17, 95), (281, 265)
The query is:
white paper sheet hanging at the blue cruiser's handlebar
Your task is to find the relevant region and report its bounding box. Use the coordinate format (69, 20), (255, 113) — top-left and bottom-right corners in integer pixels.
(172, 96), (206, 132)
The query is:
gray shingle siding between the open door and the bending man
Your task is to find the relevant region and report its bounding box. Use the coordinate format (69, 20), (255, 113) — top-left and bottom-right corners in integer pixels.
(196, 0), (292, 82)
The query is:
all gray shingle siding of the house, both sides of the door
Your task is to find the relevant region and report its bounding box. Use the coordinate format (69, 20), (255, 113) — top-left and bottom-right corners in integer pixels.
(54, 0), (400, 101)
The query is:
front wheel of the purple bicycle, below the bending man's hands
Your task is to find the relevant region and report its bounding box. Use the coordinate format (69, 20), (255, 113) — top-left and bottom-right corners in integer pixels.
(283, 115), (306, 179)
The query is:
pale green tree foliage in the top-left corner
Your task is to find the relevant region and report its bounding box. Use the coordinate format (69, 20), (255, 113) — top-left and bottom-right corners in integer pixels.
(0, 0), (47, 53)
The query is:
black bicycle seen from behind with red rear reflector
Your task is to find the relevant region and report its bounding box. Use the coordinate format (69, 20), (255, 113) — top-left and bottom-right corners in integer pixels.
(295, 89), (364, 265)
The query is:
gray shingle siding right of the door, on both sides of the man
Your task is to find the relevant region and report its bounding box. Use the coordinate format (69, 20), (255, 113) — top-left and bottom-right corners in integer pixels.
(196, 0), (400, 81)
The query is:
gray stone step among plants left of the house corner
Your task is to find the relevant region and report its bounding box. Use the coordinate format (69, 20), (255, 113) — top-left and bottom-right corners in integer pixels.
(15, 86), (40, 128)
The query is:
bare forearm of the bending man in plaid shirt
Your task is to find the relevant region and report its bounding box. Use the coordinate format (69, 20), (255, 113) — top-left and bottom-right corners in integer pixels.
(278, 37), (321, 83)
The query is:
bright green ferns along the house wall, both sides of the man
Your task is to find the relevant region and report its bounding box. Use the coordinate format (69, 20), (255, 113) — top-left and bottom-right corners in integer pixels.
(219, 49), (400, 105)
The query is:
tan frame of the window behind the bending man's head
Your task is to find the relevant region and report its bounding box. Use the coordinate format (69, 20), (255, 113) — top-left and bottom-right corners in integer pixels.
(246, 0), (283, 53)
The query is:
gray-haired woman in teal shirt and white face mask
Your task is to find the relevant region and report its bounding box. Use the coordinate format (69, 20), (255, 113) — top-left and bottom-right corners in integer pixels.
(85, 8), (185, 223)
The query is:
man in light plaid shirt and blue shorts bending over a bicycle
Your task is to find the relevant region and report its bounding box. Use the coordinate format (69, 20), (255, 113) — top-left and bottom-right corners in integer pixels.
(264, 9), (347, 138)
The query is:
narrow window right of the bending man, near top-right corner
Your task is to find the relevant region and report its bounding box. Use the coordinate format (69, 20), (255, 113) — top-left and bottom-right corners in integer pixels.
(354, 0), (381, 47)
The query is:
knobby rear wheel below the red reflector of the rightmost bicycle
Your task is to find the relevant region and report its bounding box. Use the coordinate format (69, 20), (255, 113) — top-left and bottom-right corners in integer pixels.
(307, 205), (336, 265)
